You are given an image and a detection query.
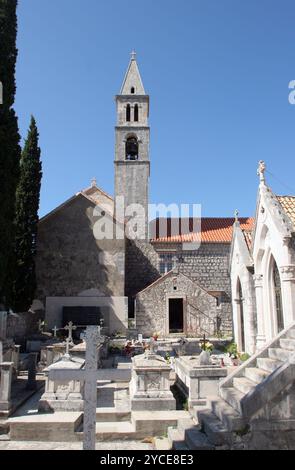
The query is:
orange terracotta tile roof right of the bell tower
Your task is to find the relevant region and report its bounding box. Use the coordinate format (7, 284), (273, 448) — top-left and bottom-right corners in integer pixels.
(150, 217), (254, 243)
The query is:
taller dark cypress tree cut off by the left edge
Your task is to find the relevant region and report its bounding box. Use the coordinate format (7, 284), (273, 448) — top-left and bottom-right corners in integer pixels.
(0, 0), (21, 304)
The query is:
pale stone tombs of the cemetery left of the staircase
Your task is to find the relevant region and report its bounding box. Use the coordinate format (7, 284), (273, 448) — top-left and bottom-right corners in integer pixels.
(0, 310), (238, 449)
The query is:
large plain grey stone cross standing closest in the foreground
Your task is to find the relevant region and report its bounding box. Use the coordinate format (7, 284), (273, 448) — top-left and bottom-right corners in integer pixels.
(48, 326), (131, 450)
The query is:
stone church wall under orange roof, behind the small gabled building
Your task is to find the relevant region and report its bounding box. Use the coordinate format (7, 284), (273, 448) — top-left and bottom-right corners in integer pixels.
(125, 241), (232, 335)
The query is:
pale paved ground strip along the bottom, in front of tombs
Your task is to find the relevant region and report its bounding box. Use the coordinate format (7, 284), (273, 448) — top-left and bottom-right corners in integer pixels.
(0, 441), (153, 451)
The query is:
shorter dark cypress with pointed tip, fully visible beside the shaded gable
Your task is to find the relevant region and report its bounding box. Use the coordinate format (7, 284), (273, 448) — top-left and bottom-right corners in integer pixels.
(12, 116), (42, 312)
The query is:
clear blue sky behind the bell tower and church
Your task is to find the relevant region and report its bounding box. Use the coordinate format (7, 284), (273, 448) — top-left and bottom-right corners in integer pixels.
(15, 0), (295, 217)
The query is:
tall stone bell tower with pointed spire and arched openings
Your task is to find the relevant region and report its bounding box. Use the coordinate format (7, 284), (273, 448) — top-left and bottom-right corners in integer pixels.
(115, 52), (150, 238)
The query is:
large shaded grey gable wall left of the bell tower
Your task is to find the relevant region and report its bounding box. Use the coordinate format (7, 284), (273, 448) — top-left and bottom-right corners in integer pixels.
(36, 195), (125, 303)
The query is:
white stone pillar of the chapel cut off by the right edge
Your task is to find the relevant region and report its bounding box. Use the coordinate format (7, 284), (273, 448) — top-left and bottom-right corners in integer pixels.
(280, 265), (295, 328)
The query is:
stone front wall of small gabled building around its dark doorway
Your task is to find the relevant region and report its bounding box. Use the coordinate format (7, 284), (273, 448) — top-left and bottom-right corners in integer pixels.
(136, 272), (218, 336)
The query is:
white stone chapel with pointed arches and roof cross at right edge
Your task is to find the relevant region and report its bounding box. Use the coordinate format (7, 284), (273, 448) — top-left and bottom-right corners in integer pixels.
(230, 162), (295, 353)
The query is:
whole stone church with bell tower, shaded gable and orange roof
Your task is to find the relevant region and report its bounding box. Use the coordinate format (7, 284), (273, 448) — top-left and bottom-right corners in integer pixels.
(34, 54), (260, 342)
